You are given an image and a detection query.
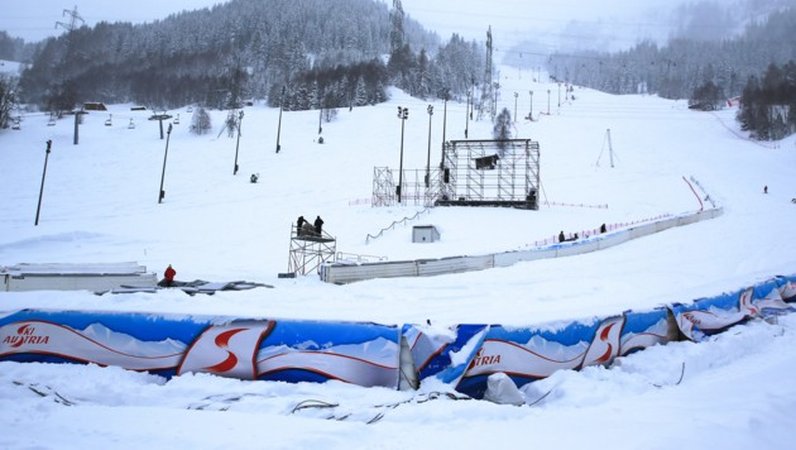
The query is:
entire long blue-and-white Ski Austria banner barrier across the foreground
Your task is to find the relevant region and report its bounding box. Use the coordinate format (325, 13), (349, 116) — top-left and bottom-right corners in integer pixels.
(0, 276), (796, 398)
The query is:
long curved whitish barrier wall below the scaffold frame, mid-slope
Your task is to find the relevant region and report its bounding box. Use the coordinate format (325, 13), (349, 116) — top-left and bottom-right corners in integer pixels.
(321, 208), (723, 284)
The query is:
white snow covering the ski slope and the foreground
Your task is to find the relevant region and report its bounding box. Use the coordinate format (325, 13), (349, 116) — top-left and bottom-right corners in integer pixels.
(0, 68), (796, 449)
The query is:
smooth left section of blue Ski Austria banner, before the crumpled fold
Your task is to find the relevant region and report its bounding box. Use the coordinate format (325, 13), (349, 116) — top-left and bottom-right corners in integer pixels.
(0, 310), (401, 388)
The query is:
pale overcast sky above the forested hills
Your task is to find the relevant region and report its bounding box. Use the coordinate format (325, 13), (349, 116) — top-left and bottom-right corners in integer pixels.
(0, 0), (687, 45)
